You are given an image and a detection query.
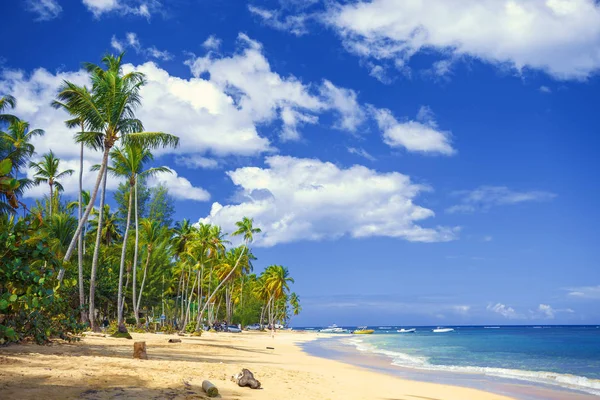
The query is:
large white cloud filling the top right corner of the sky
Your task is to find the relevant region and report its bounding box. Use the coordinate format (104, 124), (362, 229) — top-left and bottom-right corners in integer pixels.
(322, 0), (600, 79)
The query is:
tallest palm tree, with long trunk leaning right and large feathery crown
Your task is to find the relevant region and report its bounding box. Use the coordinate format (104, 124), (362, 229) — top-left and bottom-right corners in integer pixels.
(57, 53), (179, 268)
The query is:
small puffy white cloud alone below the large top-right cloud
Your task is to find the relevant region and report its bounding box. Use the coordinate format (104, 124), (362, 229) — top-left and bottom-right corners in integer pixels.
(371, 106), (456, 155)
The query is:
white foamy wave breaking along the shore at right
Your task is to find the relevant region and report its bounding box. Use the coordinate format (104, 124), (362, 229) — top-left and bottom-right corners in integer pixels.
(349, 339), (600, 396)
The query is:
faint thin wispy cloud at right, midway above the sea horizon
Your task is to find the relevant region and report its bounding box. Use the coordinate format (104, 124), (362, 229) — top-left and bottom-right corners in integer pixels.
(446, 186), (556, 214)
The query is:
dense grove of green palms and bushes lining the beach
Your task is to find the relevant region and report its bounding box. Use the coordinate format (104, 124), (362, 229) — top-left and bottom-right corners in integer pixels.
(0, 55), (300, 344)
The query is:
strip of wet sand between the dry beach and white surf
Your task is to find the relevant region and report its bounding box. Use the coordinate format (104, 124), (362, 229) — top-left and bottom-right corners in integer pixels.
(302, 335), (599, 400)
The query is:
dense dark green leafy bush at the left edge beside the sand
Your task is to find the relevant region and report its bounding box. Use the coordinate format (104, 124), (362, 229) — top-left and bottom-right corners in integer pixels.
(0, 216), (83, 344)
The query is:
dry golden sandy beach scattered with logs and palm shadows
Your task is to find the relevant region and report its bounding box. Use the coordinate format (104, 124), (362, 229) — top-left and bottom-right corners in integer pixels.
(0, 332), (508, 400)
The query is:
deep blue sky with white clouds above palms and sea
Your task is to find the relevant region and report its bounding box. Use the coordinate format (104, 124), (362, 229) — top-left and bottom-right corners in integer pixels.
(0, 0), (600, 326)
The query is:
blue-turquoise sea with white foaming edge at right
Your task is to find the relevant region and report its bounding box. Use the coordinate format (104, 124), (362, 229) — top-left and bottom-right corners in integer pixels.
(302, 326), (600, 396)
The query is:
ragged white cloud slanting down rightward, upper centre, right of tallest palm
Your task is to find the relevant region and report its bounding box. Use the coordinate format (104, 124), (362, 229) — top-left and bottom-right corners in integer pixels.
(187, 33), (364, 140)
